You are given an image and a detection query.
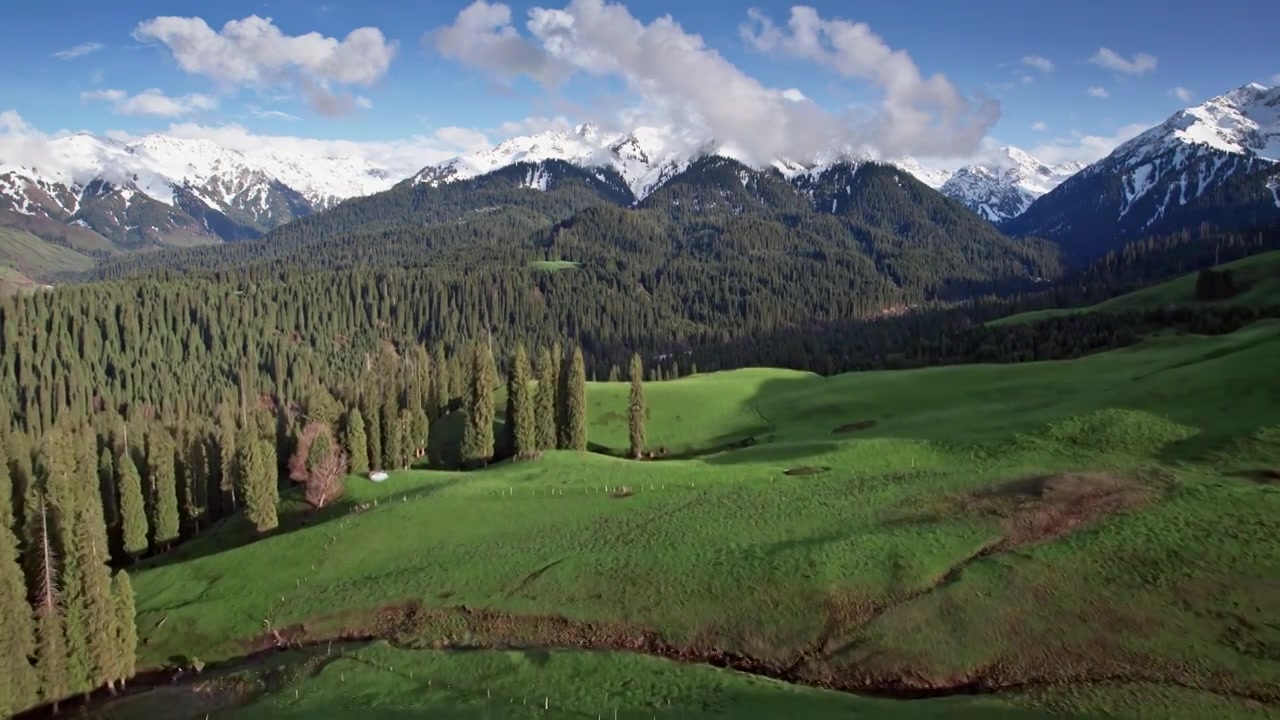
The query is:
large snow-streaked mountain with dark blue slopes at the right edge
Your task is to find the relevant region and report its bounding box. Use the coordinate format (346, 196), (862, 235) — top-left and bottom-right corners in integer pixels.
(1001, 83), (1280, 259)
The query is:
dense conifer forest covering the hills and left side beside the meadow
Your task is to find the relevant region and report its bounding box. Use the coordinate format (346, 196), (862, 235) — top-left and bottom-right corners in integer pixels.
(0, 144), (1280, 715)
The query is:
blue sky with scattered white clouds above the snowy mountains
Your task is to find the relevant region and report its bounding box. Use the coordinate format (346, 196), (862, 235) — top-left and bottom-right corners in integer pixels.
(0, 0), (1280, 161)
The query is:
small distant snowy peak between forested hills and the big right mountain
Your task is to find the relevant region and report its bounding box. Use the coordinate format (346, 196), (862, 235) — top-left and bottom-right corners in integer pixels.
(936, 146), (1084, 223)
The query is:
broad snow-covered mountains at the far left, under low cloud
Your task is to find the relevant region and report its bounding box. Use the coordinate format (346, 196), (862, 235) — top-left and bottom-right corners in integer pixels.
(0, 133), (398, 247)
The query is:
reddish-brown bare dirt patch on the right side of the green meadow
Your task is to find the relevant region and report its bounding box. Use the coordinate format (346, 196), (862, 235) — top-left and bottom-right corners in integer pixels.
(957, 473), (1160, 550)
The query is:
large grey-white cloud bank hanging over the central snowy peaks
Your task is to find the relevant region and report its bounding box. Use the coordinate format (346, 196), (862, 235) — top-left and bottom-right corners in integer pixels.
(424, 0), (1000, 163)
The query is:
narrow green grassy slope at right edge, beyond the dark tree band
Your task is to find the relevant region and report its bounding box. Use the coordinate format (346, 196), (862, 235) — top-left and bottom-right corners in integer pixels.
(988, 250), (1280, 325)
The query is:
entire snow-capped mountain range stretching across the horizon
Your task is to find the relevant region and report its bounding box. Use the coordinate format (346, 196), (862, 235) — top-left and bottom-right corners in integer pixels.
(0, 85), (1280, 275)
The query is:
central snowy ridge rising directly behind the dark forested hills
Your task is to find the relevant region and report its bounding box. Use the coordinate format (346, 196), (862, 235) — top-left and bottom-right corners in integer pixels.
(413, 124), (950, 201)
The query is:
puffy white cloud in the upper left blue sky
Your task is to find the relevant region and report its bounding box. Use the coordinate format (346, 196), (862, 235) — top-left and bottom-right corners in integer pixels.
(133, 15), (397, 115)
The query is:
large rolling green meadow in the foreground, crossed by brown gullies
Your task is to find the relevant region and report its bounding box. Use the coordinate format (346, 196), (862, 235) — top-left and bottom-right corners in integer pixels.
(113, 322), (1280, 719)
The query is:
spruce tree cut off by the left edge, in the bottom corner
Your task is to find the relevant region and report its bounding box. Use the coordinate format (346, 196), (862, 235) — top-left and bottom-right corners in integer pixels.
(0, 484), (40, 717)
